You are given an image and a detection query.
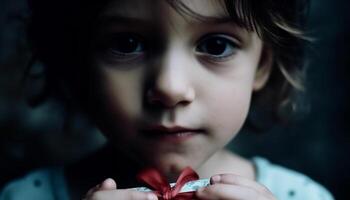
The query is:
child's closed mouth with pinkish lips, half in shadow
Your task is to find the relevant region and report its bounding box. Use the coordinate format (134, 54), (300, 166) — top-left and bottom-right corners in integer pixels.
(141, 125), (204, 143)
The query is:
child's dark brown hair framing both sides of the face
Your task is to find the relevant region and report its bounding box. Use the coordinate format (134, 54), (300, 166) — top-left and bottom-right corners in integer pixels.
(29, 0), (309, 128)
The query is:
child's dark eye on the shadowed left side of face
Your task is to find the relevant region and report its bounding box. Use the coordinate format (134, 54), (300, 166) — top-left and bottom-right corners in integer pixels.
(102, 33), (145, 61)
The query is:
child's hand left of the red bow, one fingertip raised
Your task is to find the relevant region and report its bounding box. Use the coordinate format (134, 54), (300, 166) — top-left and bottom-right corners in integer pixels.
(83, 178), (158, 200)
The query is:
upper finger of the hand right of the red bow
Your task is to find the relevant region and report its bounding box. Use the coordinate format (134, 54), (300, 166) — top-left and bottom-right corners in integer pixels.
(210, 174), (271, 193)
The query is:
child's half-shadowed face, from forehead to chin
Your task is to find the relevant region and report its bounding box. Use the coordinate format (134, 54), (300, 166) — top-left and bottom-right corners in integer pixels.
(92, 0), (268, 173)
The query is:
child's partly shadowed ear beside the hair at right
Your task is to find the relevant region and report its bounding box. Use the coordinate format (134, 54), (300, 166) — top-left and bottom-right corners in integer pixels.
(253, 45), (274, 92)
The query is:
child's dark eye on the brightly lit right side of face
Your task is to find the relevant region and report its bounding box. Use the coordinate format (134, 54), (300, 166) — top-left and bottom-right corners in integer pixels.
(196, 34), (238, 59)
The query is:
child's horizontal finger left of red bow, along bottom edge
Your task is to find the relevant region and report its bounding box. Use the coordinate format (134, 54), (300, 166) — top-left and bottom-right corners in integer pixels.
(90, 189), (158, 200)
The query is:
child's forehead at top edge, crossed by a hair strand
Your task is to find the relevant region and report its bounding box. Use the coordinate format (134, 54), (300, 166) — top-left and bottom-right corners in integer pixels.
(102, 0), (228, 20)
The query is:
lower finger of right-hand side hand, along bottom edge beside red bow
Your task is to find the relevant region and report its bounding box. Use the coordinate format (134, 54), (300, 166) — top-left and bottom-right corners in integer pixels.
(196, 183), (268, 200)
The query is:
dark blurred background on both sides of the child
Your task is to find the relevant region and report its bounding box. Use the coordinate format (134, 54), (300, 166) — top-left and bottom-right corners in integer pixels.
(0, 0), (350, 199)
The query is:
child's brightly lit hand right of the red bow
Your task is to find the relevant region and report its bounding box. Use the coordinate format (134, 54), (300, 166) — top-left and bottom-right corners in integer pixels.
(196, 174), (276, 200)
